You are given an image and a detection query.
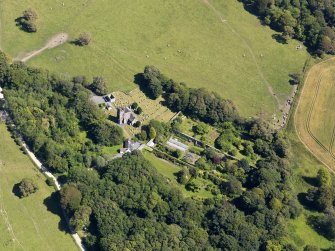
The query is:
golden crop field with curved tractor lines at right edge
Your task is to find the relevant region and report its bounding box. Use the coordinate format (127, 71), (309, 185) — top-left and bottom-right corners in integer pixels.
(294, 59), (335, 172)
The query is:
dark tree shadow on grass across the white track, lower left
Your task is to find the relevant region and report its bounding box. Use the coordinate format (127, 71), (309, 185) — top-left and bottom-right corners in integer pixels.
(43, 192), (71, 233)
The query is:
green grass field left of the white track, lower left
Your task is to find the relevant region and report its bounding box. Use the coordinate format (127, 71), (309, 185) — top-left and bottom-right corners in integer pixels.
(0, 123), (78, 251)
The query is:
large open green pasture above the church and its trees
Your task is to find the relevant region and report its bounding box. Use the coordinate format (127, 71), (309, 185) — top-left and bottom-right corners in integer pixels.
(0, 0), (308, 118)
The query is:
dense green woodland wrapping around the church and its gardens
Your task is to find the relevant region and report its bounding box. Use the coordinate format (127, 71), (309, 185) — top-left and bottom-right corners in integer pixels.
(0, 54), (334, 251)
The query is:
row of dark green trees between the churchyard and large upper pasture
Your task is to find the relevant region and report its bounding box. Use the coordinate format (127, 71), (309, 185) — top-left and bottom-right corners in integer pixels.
(140, 66), (239, 124)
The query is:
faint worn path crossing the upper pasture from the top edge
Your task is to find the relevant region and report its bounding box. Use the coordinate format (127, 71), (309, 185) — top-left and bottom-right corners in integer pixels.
(202, 0), (281, 113)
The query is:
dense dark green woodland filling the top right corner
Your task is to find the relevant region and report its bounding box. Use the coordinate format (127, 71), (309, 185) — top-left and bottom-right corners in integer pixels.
(242, 0), (335, 54)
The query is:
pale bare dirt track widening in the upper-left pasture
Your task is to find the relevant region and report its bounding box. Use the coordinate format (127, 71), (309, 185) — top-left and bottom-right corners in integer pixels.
(14, 33), (69, 62)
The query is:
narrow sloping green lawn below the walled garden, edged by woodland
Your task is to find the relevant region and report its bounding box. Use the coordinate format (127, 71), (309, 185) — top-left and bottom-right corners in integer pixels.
(143, 151), (213, 198)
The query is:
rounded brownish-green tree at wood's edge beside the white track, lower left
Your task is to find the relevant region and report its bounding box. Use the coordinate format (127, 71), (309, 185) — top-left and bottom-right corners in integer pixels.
(60, 184), (82, 212)
